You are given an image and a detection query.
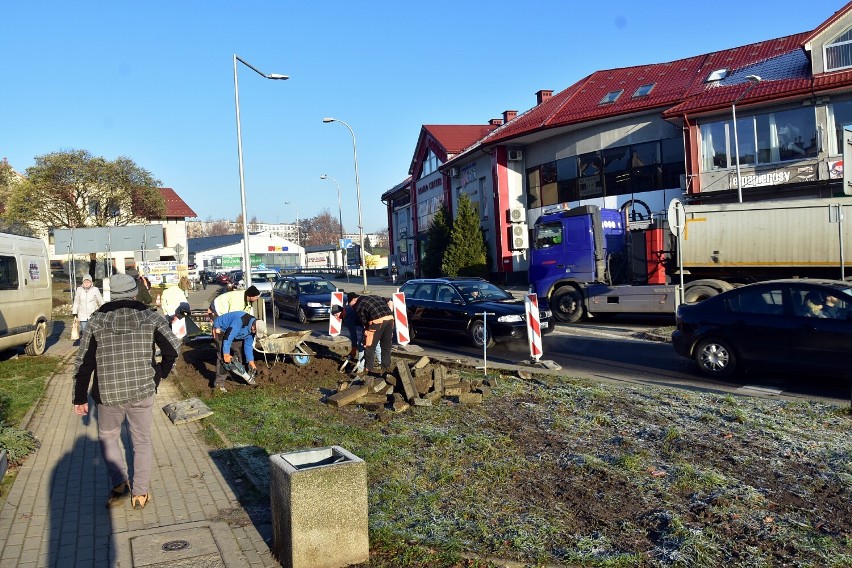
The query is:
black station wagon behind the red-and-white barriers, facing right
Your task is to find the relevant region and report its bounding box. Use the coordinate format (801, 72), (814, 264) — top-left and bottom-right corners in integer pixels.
(400, 278), (553, 347)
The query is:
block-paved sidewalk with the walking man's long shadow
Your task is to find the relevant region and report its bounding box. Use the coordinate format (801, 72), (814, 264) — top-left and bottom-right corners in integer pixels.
(0, 300), (279, 568)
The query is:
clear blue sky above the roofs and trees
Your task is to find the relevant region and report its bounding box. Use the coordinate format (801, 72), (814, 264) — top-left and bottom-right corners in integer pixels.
(0, 0), (844, 232)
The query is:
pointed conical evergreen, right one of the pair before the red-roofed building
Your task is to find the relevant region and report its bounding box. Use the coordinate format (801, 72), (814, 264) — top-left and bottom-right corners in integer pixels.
(441, 193), (488, 277)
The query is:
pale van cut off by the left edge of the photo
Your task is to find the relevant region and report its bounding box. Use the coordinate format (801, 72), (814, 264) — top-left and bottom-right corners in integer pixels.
(0, 233), (53, 355)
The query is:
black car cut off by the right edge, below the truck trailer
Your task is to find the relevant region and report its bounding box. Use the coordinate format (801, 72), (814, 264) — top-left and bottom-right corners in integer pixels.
(672, 278), (852, 377)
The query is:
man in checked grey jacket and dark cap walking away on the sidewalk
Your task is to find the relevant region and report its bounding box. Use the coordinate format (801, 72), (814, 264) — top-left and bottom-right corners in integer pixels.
(73, 274), (181, 509)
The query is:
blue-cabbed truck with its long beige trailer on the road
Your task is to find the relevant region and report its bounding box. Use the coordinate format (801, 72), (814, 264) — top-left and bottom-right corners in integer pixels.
(529, 197), (852, 323)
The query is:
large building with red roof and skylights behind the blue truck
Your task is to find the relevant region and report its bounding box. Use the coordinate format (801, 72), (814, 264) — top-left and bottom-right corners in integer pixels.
(383, 2), (852, 282)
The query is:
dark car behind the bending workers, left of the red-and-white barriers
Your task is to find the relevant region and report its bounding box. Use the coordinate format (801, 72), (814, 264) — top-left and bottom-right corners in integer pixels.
(272, 276), (337, 323)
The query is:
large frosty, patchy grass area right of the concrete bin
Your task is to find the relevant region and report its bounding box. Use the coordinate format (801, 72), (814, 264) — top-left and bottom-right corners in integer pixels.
(175, 364), (852, 568)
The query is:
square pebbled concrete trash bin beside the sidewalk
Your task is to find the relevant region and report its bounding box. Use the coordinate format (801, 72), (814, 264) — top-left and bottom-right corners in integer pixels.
(269, 446), (370, 568)
